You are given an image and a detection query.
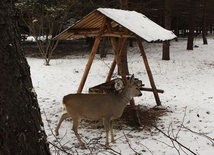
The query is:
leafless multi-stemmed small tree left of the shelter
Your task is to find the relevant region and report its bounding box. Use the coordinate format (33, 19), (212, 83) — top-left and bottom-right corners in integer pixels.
(16, 0), (72, 65)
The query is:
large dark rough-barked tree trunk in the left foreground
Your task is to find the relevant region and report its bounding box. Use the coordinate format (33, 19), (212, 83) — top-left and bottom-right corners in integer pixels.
(0, 0), (50, 155)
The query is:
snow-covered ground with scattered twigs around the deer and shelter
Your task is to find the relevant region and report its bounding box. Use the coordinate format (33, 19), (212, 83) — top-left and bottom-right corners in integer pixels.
(27, 37), (214, 155)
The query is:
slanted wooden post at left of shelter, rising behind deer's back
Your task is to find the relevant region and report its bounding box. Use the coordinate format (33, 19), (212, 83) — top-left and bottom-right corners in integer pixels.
(77, 17), (106, 93)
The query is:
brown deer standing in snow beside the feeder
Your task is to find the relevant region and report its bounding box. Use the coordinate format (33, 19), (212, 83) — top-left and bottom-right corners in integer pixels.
(55, 75), (142, 149)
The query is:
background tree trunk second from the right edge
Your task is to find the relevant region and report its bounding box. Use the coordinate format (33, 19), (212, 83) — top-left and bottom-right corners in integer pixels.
(187, 0), (197, 50)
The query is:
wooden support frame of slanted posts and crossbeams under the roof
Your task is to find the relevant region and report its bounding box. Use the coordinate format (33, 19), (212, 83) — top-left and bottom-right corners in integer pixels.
(74, 17), (161, 106)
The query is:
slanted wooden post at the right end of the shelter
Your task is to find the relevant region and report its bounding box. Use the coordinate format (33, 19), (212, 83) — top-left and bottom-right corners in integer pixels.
(136, 36), (161, 106)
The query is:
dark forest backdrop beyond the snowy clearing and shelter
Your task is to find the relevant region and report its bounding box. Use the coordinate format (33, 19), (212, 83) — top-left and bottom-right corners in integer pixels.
(16, 0), (214, 65)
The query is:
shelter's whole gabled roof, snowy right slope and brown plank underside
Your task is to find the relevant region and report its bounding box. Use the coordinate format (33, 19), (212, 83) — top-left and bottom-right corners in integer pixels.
(55, 8), (176, 42)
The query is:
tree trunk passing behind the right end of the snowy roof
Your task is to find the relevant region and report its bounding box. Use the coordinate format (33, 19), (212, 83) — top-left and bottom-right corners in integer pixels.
(162, 0), (171, 60)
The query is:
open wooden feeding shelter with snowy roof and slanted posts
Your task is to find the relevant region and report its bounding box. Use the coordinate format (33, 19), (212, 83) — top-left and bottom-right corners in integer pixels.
(54, 8), (176, 105)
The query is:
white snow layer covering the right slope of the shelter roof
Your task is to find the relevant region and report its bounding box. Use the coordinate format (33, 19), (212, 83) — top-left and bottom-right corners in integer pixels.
(97, 8), (176, 42)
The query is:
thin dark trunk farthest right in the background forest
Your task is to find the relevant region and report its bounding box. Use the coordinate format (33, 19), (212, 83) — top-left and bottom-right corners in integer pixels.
(202, 0), (208, 44)
